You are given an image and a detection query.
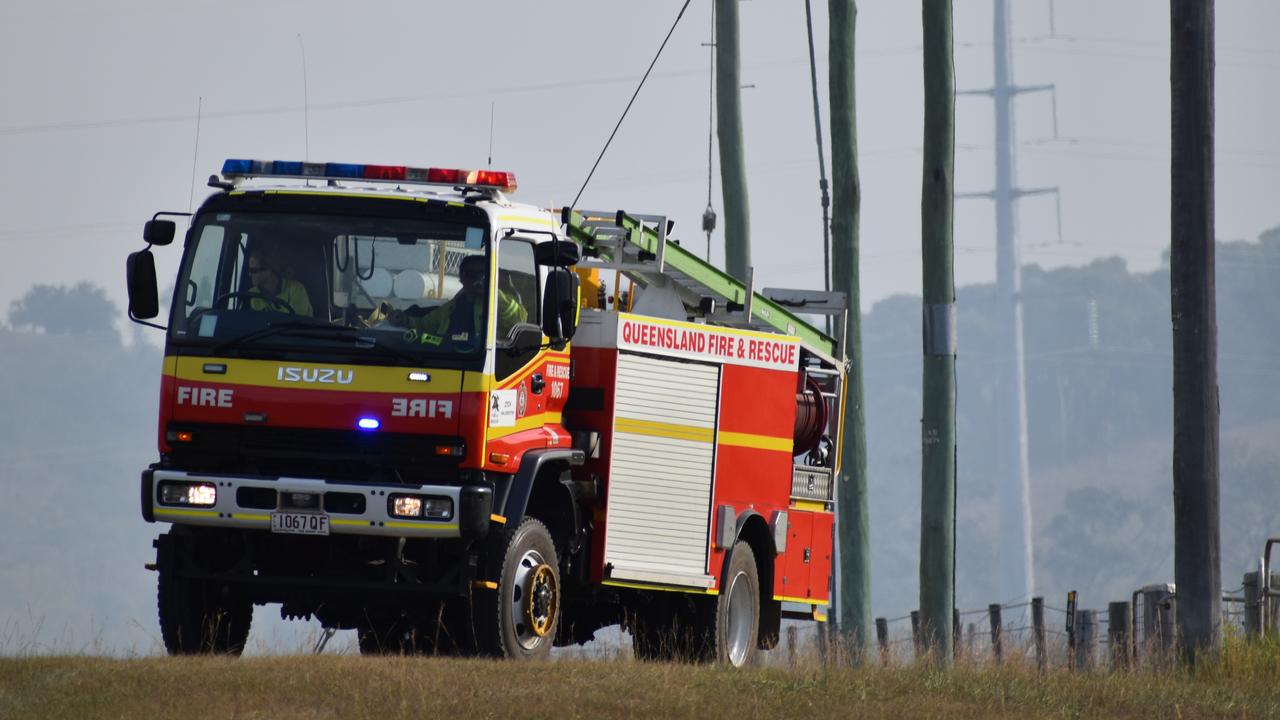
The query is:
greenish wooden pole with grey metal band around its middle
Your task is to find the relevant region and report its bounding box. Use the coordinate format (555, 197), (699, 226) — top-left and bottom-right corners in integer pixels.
(920, 0), (956, 665)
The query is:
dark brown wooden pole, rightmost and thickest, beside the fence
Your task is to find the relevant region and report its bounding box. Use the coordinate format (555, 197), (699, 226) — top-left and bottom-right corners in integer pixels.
(1169, 0), (1222, 665)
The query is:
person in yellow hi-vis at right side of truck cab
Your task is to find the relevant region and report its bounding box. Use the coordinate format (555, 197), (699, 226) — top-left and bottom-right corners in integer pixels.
(389, 255), (529, 346)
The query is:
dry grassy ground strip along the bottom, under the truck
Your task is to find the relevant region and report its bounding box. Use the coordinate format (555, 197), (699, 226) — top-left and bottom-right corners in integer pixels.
(0, 642), (1280, 720)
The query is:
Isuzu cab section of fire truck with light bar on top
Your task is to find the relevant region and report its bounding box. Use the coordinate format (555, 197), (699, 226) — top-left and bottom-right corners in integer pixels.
(129, 160), (581, 655)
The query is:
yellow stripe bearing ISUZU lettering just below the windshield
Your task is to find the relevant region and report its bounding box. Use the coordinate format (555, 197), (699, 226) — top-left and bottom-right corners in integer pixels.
(164, 356), (488, 395)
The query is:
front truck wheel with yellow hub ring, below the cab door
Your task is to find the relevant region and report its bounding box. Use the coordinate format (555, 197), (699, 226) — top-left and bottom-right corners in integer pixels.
(472, 518), (561, 660)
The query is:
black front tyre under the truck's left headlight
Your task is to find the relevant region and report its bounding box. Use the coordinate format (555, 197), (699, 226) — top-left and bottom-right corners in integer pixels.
(156, 568), (253, 656)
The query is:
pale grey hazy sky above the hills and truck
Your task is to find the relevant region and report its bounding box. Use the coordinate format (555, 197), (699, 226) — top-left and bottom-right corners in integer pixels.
(0, 0), (1280, 325)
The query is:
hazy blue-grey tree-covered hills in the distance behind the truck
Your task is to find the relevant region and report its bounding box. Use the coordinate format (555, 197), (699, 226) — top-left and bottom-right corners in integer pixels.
(0, 229), (1280, 650)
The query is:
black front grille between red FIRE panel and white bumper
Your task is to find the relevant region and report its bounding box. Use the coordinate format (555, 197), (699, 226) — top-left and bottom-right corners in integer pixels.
(168, 423), (460, 481)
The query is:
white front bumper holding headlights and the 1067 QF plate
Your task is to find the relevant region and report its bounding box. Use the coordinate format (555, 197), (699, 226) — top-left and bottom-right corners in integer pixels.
(142, 468), (493, 538)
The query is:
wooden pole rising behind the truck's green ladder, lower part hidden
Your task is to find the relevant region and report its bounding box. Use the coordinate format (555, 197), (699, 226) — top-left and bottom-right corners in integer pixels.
(716, 0), (751, 282)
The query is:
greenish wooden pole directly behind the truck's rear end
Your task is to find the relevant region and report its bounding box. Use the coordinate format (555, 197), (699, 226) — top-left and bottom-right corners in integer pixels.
(828, 0), (872, 662)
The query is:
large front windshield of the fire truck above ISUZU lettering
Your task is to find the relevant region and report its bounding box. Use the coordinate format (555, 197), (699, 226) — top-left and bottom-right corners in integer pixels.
(170, 213), (489, 355)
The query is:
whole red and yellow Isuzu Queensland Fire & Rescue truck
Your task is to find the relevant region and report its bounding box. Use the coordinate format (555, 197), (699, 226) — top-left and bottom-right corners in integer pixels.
(128, 160), (846, 665)
